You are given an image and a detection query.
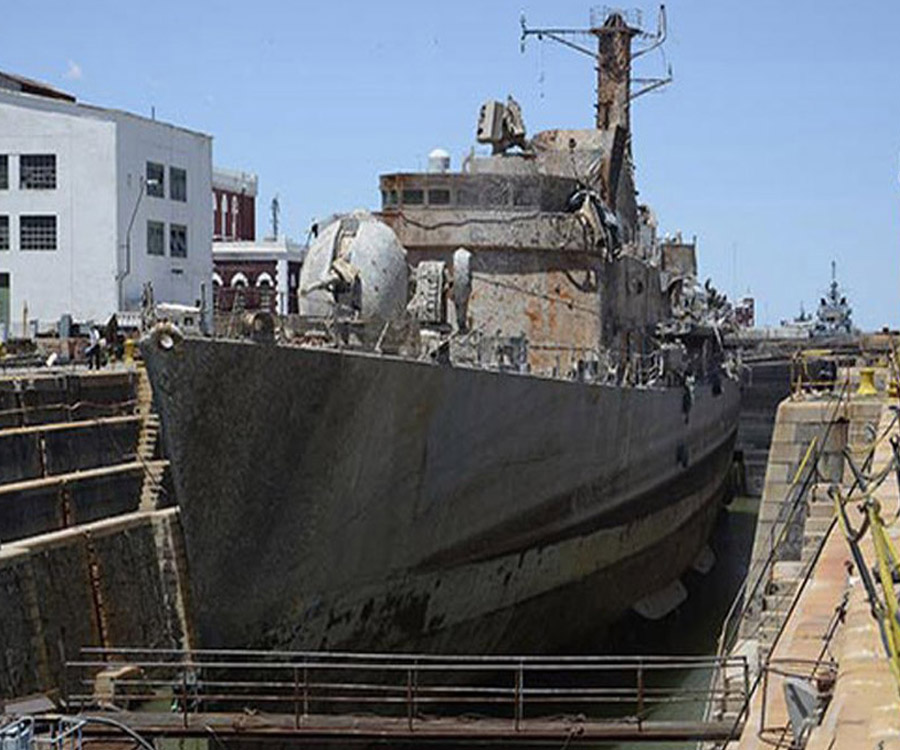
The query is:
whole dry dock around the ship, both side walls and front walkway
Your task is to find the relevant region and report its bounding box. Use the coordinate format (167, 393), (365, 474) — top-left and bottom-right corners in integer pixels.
(7, 354), (900, 750)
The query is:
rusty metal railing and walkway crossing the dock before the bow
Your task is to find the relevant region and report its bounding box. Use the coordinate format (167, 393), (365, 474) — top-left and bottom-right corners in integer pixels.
(65, 648), (749, 730)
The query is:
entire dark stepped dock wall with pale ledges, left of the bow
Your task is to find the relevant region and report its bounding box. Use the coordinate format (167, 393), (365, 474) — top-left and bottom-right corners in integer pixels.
(0, 367), (189, 714)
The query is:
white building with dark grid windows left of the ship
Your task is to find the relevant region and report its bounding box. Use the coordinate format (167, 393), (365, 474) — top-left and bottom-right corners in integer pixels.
(0, 74), (212, 334)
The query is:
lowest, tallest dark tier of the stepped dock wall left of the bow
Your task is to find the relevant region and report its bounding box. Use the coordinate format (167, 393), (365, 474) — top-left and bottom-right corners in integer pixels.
(0, 509), (190, 698)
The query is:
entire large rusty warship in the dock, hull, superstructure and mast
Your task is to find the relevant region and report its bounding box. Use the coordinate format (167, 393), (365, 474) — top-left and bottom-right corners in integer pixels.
(142, 14), (739, 652)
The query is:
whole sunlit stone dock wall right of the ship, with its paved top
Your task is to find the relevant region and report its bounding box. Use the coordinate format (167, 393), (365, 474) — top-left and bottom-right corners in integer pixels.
(712, 358), (900, 750)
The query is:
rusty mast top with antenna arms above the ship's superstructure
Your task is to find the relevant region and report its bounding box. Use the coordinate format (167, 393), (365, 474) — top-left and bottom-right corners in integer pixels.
(519, 5), (672, 130)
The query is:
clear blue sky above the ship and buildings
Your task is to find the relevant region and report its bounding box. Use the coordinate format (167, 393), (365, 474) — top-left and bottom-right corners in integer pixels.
(0, 0), (900, 329)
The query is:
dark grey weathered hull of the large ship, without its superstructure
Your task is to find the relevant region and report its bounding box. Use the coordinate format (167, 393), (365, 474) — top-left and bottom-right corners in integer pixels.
(143, 338), (739, 651)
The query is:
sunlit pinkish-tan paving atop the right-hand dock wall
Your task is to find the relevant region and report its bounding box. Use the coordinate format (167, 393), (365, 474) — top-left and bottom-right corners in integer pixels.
(728, 384), (900, 750)
